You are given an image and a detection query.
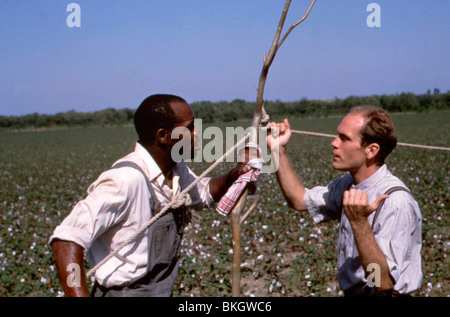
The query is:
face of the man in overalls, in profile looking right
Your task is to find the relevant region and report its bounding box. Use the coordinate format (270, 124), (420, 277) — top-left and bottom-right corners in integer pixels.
(171, 102), (197, 159)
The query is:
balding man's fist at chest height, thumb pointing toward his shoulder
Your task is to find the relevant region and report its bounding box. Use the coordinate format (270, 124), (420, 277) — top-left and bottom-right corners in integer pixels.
(342, 189), (389, 224)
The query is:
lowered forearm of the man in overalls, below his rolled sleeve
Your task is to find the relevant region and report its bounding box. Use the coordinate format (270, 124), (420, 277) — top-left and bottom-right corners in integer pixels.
(51, 240), (90, 297)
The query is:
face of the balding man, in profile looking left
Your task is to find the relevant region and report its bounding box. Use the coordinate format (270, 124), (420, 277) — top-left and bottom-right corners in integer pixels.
(331, 114), (366, 173)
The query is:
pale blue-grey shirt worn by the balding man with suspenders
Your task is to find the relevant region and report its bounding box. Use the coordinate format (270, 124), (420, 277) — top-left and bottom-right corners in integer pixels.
(304, 165), (422, 293)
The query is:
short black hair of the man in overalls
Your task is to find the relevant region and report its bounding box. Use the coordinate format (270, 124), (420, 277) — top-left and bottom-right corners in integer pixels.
(134, 94), (186, 143)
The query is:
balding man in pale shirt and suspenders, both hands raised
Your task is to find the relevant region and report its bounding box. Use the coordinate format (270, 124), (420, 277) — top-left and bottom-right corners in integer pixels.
(267, 106), (422, 296)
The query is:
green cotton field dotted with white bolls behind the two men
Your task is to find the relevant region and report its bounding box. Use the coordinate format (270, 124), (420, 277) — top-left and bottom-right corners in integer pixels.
(0, 112), (450, 297)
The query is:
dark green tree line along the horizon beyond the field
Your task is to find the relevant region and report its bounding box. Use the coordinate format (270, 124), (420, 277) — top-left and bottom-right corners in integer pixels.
(0, 89), (450, 129)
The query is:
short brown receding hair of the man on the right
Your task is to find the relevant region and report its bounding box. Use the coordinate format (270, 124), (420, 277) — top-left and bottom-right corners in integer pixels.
(349, 105), (397, 165)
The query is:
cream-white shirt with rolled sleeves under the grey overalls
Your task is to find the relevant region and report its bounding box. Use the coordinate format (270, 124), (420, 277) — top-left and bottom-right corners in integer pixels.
(50, 143), (214, 287)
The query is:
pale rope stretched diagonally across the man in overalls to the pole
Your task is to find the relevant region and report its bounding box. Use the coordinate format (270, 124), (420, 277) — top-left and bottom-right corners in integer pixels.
(87, 132), (251, 278)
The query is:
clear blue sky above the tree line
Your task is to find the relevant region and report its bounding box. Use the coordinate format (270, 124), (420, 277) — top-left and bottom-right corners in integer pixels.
(0, 0), (450, 116)
